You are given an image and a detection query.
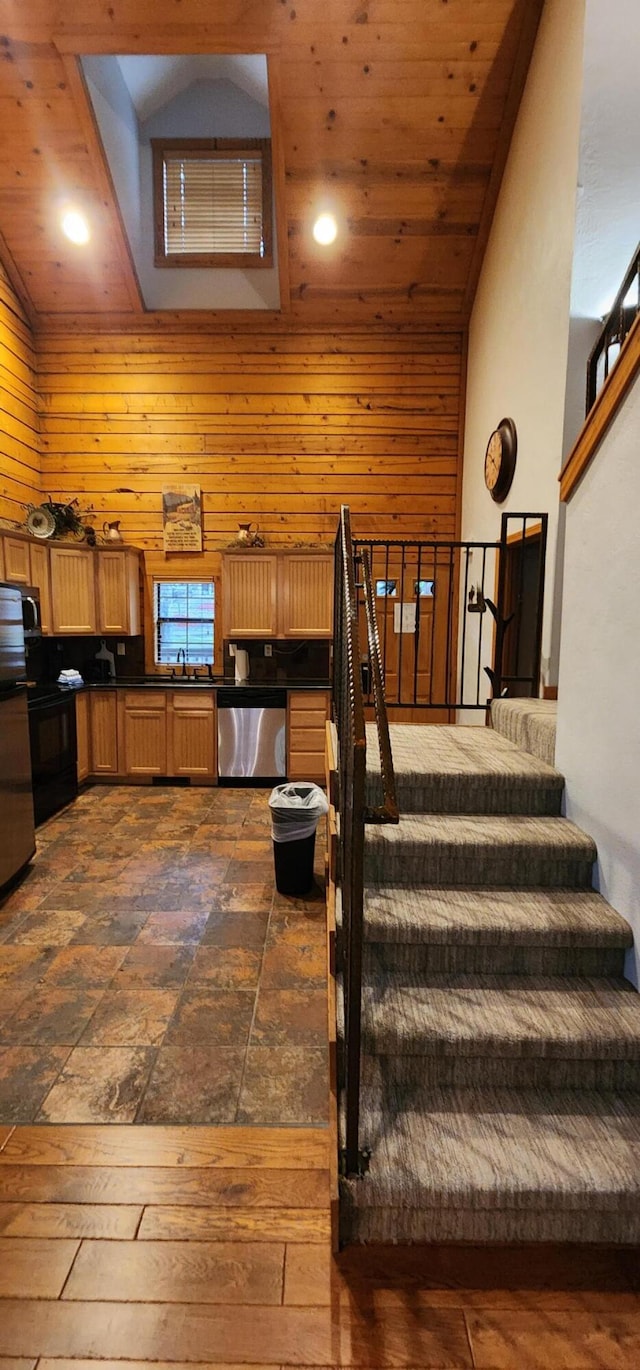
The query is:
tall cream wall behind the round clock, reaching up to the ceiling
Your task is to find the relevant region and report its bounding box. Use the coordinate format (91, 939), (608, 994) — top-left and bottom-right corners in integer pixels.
(462, 0), (584, 706)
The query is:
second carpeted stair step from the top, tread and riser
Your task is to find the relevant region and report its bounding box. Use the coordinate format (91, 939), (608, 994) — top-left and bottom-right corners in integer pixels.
(365, 814), (596, 888)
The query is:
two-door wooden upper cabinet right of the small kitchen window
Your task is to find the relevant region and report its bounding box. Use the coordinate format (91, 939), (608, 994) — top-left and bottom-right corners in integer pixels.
(222, 551), (333, 638)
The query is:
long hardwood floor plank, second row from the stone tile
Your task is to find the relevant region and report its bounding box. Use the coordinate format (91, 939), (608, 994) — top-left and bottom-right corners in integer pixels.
(0, 1161), (329, 1208)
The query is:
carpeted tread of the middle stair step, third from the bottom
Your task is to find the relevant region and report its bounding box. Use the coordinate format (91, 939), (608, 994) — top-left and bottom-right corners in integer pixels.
(365, 885), (633, 949)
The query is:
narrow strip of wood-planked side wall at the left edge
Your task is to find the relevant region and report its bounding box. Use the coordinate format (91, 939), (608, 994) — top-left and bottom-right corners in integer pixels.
(0, 264), (41, 523)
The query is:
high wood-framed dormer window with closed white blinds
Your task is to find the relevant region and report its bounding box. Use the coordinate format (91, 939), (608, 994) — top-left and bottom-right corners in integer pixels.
(151, 138), (273, 267)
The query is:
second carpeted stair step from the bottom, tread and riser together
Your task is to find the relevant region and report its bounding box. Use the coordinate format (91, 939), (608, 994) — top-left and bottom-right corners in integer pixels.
(362, 975), (640, 1090)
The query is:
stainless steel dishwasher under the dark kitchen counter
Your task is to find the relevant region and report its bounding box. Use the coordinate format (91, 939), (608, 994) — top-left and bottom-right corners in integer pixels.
(218, 685), (286, 785)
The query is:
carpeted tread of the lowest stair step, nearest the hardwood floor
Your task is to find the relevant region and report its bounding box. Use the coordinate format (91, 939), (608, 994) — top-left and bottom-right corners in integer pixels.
(344, 1089), (640, 1216)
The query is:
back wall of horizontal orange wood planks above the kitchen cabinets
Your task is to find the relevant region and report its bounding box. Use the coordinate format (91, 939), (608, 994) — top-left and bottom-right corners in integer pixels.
(38, 325), (462, 574)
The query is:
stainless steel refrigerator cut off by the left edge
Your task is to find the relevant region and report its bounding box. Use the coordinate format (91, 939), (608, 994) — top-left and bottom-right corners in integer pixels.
(0, 584), (36, 891)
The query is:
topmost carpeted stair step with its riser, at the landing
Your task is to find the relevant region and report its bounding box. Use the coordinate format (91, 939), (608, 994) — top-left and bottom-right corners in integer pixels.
(367, 723), (565, 815)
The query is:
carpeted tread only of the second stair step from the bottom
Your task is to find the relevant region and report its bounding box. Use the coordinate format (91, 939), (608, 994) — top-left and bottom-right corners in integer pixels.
(363, 975), (640, 1057)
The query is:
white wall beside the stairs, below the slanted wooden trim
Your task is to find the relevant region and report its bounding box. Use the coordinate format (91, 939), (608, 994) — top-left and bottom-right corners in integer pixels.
(555, 369), (640, 985)
